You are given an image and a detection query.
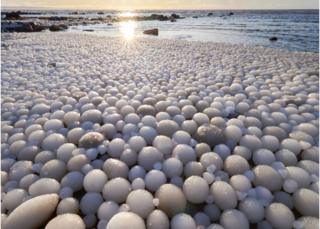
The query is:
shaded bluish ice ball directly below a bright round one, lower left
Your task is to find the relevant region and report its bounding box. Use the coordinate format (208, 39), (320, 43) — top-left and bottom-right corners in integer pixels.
(80, 192), (103, 215)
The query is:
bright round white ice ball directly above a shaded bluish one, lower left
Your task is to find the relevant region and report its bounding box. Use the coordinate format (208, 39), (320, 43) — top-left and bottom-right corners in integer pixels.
(83, 169), (108, 192)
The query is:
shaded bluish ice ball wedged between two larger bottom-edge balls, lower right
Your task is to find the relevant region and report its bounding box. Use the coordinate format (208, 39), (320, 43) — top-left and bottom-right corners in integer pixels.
(239, 197), (264, 223)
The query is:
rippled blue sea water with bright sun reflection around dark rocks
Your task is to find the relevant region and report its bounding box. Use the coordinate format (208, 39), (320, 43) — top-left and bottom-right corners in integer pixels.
(6, 10), (319, 52)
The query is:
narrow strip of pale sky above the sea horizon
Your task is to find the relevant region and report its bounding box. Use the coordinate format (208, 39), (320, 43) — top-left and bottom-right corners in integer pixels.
(1, 0), (319, 10)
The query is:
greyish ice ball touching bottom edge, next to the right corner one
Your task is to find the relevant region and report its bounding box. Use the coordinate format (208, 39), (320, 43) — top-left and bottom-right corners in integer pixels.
(266, 203), (294, 229)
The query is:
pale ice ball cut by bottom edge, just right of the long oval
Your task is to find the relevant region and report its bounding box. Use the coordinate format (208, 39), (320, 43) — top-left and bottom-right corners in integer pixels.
(45, 214), (86, 229)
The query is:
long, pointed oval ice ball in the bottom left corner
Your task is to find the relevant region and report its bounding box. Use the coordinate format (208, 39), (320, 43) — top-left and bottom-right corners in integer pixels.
(3, 194), (59, 229)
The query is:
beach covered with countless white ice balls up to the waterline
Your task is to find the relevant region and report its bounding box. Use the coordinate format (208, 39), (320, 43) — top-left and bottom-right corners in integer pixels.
(1, 32), (319, 229)
